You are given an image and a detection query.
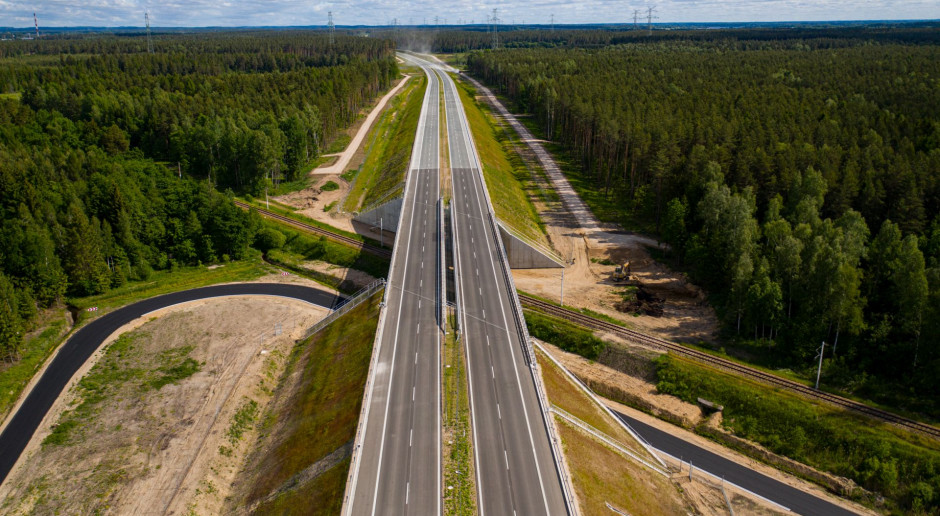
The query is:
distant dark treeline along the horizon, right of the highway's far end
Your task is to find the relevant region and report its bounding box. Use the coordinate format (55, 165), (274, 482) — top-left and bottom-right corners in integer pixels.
(392, 24), (940, 53)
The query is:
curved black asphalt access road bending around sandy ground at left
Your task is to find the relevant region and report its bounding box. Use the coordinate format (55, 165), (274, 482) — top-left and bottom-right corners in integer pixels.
(0, 283), (341, 484)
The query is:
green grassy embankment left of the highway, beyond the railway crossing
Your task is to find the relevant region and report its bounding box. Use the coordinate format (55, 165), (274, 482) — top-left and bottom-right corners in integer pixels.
(343, 75), (427, 212)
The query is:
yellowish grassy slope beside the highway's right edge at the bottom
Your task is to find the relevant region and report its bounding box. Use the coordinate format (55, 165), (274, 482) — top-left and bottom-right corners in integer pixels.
(538, 352), (688, 515)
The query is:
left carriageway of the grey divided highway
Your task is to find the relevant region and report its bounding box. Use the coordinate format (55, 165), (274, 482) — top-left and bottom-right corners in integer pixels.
(345, 54), (442, 515)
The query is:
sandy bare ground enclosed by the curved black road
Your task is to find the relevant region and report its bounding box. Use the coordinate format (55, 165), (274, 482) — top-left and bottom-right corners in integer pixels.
(0, 296), (325, 514)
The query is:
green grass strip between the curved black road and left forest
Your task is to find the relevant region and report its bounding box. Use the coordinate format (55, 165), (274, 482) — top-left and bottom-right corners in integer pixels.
(0, 253), (276, 426)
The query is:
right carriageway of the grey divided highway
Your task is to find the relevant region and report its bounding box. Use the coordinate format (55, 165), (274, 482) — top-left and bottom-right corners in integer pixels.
(430, 59), (567, 515)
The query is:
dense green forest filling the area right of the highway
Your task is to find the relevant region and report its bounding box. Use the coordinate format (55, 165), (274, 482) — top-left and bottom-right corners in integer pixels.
(468, 40), (940, 415)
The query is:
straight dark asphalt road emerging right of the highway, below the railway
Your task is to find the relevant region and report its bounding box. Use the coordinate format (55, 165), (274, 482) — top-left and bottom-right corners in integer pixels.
(616, 412), (855, 515)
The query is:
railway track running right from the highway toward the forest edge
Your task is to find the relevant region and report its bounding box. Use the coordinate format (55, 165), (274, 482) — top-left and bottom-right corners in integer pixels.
(519, 294), (940, 439)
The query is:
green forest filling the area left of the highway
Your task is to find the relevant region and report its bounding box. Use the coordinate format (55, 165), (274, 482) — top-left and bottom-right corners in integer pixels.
(0, 31), (398, 361)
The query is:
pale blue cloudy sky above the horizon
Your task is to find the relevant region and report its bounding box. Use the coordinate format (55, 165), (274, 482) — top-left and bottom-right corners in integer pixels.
(0, 0), (940, 29)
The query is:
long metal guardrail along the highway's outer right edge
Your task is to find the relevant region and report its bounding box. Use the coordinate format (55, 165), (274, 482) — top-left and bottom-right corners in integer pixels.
(442, 69), (580, 516)
